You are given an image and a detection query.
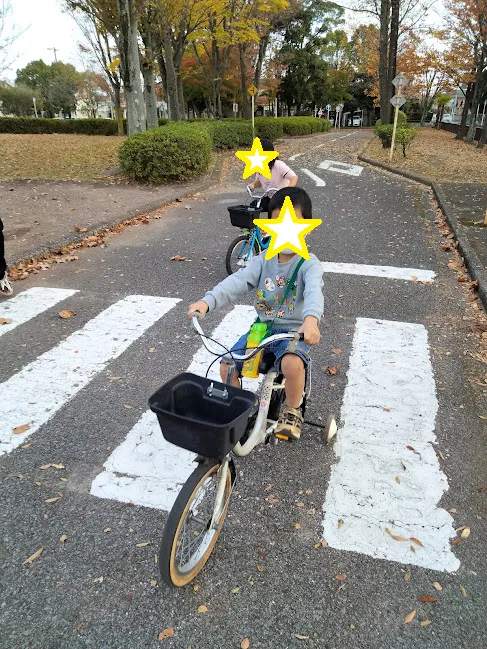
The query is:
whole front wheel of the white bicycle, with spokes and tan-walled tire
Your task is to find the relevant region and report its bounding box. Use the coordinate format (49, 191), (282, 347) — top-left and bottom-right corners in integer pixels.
(159, 460), (232, 586)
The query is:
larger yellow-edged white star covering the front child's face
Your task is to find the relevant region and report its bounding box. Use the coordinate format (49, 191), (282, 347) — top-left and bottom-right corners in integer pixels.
(254, 196), (322, 259)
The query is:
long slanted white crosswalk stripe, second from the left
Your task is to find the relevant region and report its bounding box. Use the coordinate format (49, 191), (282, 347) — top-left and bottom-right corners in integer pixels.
(0, 295), (180, 453)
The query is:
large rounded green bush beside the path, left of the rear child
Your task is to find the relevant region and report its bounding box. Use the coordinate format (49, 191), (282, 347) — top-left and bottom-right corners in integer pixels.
(119, 123), (212, 182)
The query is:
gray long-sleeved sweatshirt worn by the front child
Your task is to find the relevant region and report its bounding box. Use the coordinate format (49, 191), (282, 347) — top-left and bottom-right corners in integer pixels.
(203, 252), (323, 330)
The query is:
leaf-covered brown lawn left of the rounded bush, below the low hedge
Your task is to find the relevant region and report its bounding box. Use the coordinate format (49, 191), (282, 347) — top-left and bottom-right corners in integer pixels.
(0, 133), (125, 180)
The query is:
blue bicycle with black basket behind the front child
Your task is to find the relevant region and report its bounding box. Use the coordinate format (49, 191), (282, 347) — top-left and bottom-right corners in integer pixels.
(225, 187), (278, 275)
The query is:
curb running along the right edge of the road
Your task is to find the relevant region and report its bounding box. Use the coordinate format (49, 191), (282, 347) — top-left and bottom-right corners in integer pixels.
(358, 155), (487, 310)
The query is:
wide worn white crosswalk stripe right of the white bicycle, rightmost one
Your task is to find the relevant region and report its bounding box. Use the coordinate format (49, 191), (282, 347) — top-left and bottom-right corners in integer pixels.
(323, 318), (460, 572)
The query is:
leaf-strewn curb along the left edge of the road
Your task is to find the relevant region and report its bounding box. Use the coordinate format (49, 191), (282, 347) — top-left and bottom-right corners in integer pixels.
(8, 157), (224, 268)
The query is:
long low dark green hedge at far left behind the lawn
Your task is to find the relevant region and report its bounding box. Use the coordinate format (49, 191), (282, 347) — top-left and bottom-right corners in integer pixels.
(0, 117), (118, 135)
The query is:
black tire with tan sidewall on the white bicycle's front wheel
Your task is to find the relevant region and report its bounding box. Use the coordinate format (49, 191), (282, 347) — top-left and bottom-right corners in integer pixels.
(159, 460), (232, 587)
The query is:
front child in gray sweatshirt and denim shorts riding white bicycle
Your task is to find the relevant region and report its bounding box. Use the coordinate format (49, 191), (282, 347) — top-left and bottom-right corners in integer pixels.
(188, 187), (323, 440)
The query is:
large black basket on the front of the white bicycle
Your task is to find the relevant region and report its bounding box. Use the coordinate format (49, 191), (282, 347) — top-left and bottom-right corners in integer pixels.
(149, 372), (257, 458)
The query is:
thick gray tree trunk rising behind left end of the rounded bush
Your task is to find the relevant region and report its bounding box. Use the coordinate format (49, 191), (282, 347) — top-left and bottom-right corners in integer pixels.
(117, 0), (145, 135)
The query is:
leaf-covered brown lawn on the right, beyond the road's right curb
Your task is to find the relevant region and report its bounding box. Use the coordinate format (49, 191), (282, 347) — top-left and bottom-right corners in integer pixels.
(364, 126), (487, 183)
